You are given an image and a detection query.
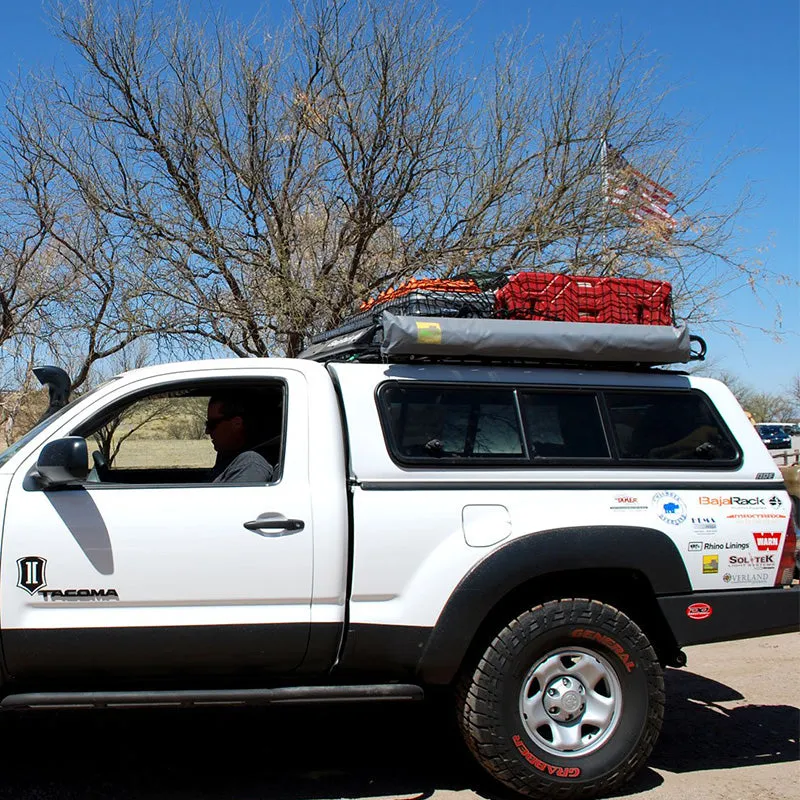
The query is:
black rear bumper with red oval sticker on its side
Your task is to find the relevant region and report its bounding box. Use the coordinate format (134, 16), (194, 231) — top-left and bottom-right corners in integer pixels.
(658, 586), (800, 647)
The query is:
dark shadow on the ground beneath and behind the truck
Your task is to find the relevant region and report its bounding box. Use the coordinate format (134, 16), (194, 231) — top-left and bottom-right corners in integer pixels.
(0, 670), (800, 800)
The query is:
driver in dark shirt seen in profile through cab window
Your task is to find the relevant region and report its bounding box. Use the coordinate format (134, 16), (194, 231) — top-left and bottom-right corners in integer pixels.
(206, 393), (273, 483)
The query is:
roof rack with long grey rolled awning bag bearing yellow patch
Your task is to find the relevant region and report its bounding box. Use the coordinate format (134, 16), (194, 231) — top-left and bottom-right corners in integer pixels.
(300, 311), (706, 369)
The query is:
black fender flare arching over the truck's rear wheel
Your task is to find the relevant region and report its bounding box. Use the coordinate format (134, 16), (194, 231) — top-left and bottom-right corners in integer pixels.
(417, 525), (692, 684)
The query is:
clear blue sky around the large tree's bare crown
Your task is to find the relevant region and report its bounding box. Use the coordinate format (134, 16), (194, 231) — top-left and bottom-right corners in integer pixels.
(0, 0), (800, 391)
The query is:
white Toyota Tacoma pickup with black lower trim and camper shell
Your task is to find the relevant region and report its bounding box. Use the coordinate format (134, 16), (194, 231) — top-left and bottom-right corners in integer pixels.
(0, 316), (800, 798)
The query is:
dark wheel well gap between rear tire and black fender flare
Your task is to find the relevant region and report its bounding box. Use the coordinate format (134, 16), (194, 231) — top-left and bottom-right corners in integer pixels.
(463, 569), (684, 666)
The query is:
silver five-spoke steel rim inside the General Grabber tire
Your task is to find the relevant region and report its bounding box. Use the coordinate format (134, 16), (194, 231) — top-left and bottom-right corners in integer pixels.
(519, 647), (622, 758)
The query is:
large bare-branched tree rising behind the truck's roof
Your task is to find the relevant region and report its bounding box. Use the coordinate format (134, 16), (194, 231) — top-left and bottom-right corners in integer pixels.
(4, 0), (792, 356)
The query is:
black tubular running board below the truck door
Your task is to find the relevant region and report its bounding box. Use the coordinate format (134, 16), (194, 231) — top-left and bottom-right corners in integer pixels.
(0, 683), (424, 711)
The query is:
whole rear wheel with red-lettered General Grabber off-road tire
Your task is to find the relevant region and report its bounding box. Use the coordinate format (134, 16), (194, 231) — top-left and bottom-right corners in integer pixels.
(457, 599), (664, 799)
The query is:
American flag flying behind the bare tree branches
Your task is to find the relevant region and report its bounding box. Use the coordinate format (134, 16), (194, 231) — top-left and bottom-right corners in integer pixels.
(603, 144), (678, 236)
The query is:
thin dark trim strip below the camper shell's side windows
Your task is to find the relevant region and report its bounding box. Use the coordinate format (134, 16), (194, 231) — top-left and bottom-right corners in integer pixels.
(354, 479), (786, 492)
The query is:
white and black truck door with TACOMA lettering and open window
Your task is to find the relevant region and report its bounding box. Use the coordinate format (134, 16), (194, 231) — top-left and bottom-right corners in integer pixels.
(0, 368), (314, 681)
